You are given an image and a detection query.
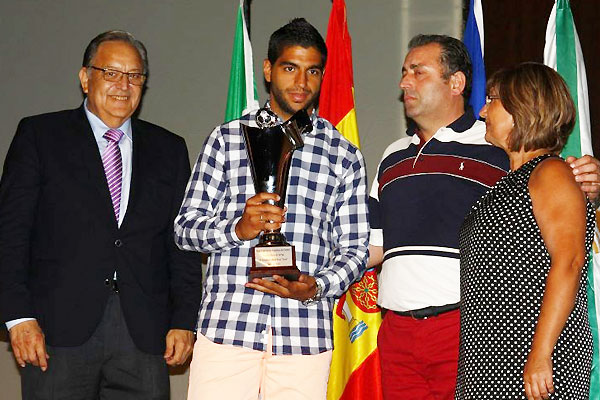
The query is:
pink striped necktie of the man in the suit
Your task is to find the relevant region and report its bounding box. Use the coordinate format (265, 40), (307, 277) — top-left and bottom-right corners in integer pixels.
(102, 129), (123, 223)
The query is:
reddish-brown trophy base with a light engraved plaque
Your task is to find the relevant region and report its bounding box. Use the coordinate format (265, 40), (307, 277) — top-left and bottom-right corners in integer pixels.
(249, 238), (300, 281)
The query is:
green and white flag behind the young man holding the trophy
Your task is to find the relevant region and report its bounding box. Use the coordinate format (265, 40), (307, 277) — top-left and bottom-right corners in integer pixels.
(225, 0), (259, 122)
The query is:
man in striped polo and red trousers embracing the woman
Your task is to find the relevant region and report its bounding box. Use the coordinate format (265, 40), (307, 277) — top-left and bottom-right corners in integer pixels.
(369, 35), (599, 400)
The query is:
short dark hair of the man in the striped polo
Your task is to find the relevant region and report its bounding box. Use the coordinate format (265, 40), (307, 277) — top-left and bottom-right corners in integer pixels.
(408, 35), (473, 104)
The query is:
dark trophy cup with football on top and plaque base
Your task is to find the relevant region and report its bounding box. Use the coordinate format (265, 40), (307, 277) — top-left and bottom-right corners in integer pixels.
(242, 109), (312, 280)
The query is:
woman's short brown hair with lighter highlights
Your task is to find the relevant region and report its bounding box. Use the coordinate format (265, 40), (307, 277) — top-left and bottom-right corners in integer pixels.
(487, 62), (576, 153)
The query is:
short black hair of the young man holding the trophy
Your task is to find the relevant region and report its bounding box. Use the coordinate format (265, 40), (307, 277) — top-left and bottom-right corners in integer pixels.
(267, 18), (327, 68)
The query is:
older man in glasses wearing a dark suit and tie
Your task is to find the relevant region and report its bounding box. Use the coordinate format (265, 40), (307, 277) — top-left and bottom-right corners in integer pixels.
(0, 31), (201, 400)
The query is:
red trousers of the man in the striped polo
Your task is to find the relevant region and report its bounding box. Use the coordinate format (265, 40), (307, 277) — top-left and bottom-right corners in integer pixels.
(377, 310), (460, 400)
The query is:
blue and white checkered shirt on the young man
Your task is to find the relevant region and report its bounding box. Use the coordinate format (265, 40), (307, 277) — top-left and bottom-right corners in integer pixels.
(175, 107), (369, 355)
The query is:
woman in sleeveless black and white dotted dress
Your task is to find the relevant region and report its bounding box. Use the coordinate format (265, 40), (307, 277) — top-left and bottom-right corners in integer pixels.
(456, 63), (594, 400)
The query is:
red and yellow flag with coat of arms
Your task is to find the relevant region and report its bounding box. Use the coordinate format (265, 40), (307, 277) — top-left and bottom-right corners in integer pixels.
(319, 0), (383, 400)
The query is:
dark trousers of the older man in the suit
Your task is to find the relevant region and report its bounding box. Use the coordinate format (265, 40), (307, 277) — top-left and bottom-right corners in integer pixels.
(21, 292), (170, 400)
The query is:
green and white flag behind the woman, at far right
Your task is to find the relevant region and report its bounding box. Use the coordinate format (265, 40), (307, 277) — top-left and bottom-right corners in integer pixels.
(544, 0), (600, 400)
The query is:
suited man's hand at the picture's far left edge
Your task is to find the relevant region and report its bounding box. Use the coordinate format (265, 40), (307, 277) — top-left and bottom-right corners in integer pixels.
(9, 320), (50, 371)
